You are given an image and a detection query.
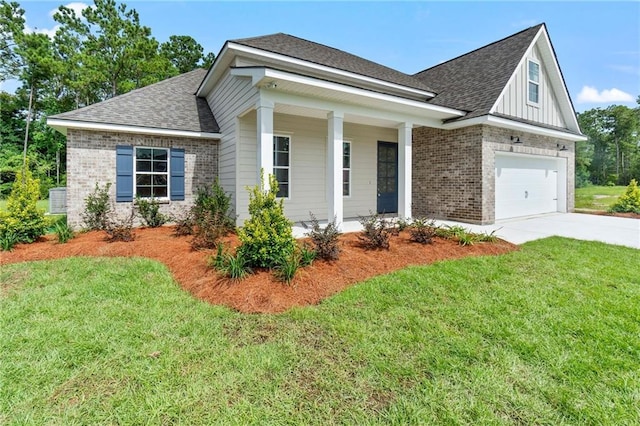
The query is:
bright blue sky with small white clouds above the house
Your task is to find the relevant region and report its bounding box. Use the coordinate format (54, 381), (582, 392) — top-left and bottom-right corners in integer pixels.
(4, 0), (640, 111)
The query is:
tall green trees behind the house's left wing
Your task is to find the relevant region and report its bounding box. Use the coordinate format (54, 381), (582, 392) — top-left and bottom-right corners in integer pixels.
(0, 0), (215, 198)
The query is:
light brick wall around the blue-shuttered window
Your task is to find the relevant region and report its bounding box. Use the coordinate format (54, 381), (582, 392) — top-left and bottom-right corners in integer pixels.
(67, 129), (218, 229)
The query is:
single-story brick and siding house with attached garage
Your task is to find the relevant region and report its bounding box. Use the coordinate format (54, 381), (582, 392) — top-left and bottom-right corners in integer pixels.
(48, 24), (586, 230)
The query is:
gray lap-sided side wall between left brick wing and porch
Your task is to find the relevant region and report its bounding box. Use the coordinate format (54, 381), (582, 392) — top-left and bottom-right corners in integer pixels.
(207, 72), (258, 216)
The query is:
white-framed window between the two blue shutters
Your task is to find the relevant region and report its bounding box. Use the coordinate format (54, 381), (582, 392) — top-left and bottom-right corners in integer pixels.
(135, 147), (169, 198)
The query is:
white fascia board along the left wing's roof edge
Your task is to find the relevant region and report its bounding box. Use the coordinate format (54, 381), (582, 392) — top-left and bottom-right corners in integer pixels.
(47, 118), (222, 139)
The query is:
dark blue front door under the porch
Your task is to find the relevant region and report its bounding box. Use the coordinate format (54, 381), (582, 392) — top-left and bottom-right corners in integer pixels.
(378, 142), (398, 214)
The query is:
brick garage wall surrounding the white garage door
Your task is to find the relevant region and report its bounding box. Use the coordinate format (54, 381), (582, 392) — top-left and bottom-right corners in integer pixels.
(412, 125), (575, 224)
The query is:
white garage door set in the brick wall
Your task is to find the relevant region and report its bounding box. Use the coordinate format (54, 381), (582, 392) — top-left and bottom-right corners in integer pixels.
(495, 154), (559, 220)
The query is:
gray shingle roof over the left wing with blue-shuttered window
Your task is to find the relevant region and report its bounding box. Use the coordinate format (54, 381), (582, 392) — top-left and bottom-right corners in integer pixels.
(49, 69), (220, 133)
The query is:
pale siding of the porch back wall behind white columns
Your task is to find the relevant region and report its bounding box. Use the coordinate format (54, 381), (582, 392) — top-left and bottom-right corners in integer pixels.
(237, 112), (398, 225)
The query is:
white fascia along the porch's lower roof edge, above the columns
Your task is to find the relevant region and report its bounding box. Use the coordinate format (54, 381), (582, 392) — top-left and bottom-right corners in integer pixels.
(231, 67), (466, 118)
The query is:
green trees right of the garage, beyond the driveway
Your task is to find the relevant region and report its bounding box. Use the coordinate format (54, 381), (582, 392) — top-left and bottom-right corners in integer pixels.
(576, 100), (640, 187)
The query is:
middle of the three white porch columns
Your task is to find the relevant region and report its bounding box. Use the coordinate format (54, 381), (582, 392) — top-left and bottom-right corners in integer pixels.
(327, 111), (344, 229)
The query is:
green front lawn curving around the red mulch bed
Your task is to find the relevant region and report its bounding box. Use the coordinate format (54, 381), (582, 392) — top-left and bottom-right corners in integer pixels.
(0, 238), (640, 424)
